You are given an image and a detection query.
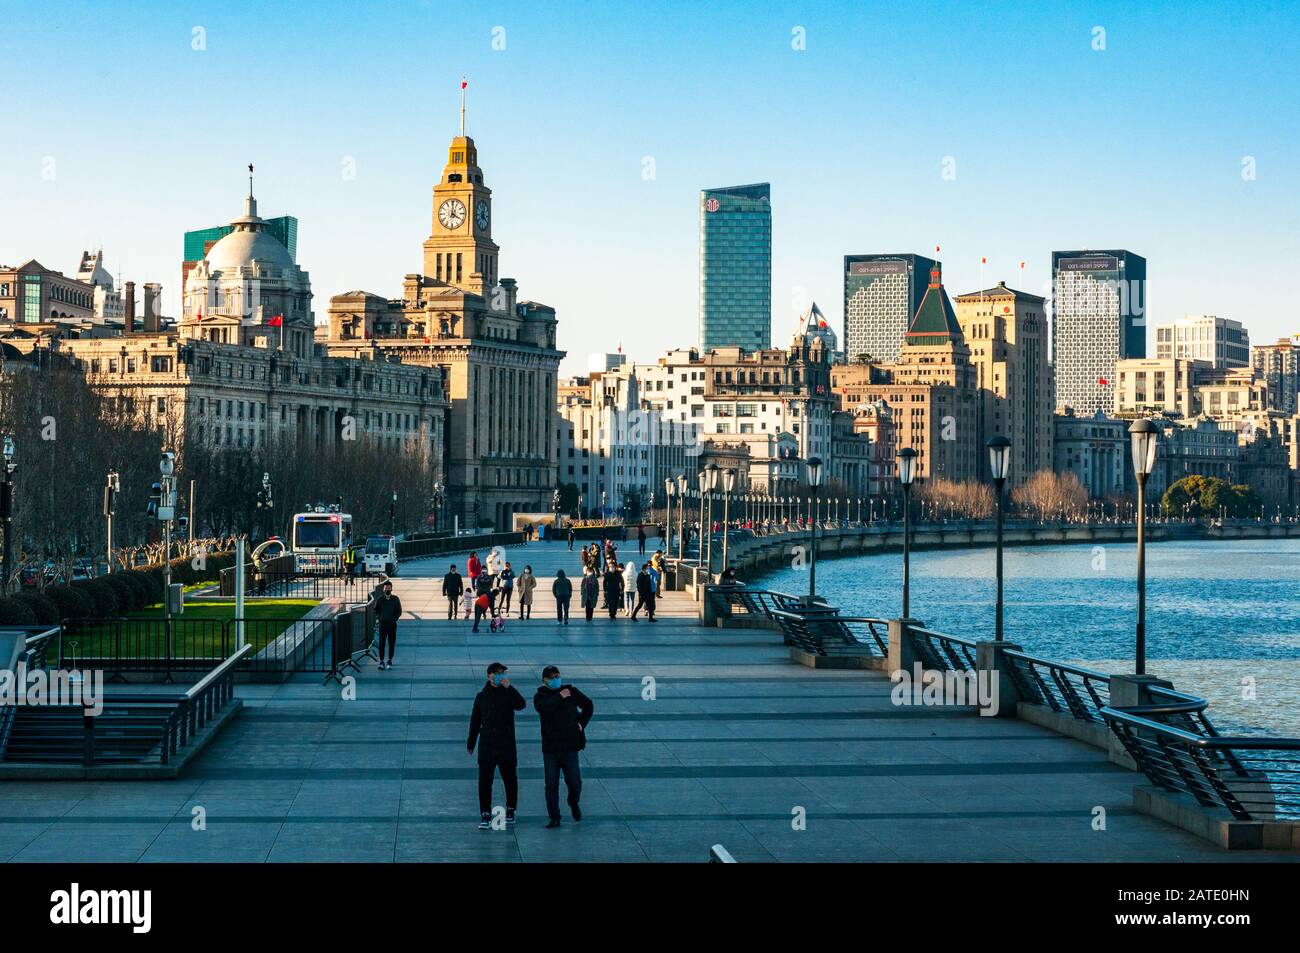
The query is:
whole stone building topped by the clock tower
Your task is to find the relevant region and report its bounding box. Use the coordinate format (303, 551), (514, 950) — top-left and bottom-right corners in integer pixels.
(320, 129), (564, 529)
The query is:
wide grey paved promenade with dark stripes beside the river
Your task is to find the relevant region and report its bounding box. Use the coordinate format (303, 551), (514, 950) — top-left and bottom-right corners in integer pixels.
(0, 543), (1294, 862)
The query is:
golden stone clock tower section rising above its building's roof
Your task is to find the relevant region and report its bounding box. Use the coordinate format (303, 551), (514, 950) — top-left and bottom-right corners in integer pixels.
(424, 134), (501, 296)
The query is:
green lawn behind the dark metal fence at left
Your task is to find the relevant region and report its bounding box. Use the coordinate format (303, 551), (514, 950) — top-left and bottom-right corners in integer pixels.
(62, 599), (319, 662)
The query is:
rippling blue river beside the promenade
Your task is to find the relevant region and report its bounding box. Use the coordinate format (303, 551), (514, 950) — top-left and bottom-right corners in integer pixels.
(751, 540), (1300, 737)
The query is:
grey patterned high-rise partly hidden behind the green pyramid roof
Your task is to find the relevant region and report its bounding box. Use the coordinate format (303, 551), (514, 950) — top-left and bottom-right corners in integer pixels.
(842, 255), (939, 364)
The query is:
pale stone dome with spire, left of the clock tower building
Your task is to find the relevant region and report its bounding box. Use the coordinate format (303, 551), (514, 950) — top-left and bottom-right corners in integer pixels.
(179, 166), (315, 358)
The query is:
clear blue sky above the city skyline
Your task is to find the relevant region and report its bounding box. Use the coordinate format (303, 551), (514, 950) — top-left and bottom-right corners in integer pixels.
(0, 0), (1300, 372)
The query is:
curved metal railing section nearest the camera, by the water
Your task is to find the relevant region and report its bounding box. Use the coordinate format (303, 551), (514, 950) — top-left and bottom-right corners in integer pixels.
(1101, 698), (1300, 822)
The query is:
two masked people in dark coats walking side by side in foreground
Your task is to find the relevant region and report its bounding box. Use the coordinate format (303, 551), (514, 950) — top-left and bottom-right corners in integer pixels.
(465, 662), (594, 831)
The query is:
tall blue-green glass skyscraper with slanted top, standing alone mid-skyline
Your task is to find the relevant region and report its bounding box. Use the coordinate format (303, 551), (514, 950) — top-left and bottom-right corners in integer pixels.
(699, 182), (772, 351)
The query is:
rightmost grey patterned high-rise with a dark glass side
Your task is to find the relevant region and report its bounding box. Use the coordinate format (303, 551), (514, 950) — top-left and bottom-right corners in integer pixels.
(1052, 250), (1148, 417)
